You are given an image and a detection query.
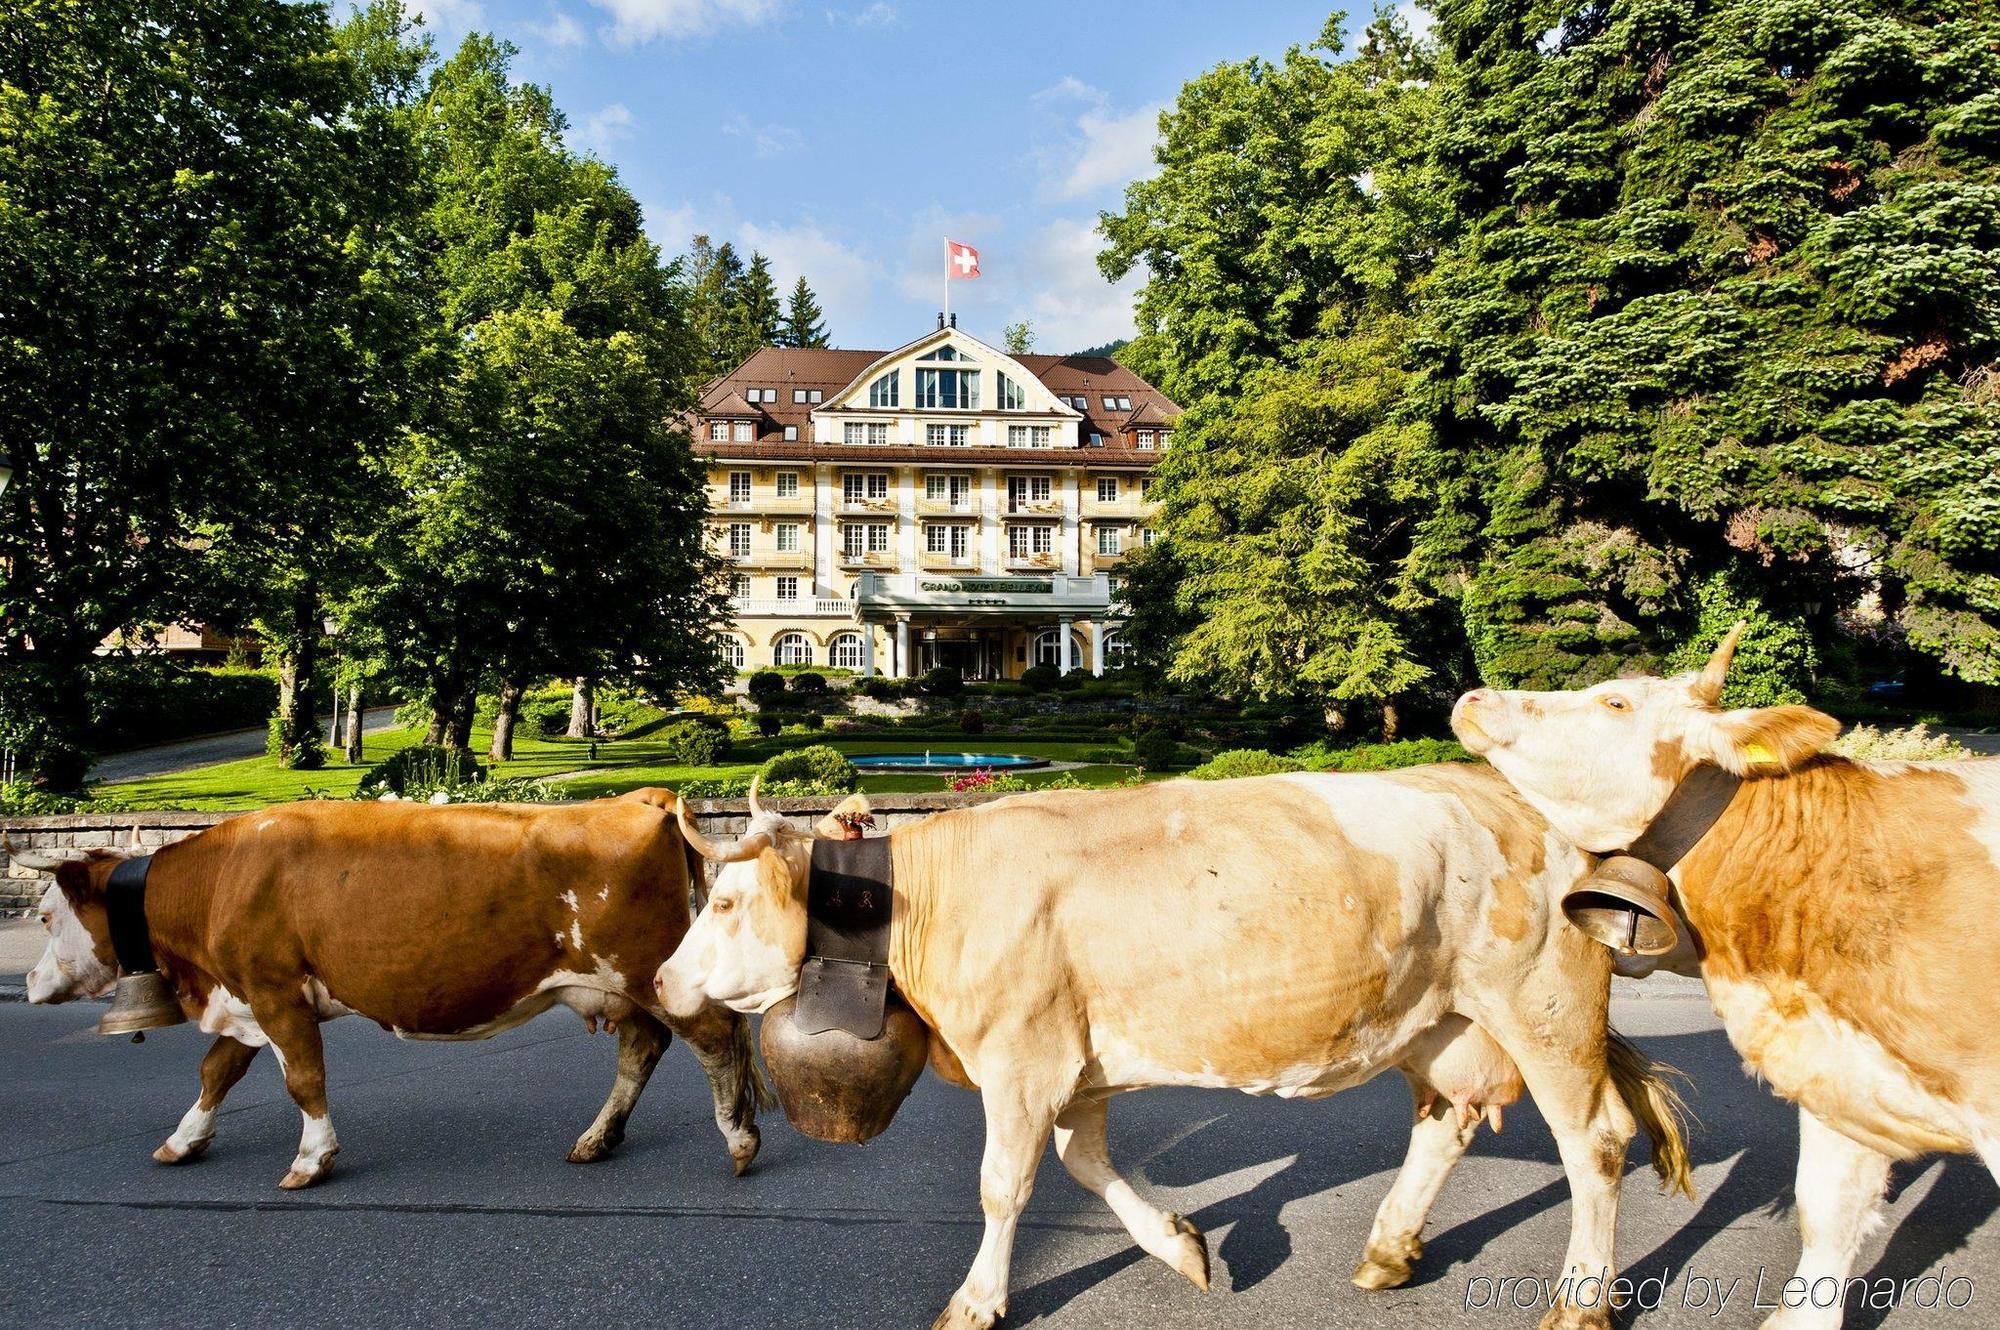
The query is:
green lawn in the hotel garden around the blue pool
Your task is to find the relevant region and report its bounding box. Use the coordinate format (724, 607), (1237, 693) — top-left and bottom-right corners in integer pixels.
(96, 730), (1132, 812)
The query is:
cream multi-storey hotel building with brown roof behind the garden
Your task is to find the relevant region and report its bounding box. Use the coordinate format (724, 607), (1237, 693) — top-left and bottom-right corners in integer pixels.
(692, 320), (1180, 678)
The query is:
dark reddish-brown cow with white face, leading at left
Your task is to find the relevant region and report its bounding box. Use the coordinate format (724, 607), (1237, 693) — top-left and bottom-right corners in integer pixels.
(16, 790), (760, 1188)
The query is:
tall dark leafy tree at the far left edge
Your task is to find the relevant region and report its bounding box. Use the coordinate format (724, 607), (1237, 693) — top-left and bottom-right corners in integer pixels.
(0, 0), (398, 790)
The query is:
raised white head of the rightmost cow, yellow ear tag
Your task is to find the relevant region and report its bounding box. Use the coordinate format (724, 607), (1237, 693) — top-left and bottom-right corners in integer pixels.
(1452, 624), (1840, 854)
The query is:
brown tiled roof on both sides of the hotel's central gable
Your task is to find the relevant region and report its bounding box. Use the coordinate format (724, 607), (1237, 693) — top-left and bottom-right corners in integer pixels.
(694, 346), (1180, 448)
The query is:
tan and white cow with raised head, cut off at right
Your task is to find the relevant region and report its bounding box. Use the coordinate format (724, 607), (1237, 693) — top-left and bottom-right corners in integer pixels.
(1452, 626), (2000, 1330)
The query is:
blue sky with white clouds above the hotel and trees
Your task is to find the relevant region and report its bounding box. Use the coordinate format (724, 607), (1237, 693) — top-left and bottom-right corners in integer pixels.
(418, 0), (1392, 352)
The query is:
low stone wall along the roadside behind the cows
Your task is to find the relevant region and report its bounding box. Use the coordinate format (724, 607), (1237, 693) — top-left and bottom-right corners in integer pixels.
(0, 794), (1000, 914)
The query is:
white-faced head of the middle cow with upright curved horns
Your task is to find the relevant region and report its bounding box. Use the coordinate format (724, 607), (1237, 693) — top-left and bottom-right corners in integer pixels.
(654, 782), (874, 1018)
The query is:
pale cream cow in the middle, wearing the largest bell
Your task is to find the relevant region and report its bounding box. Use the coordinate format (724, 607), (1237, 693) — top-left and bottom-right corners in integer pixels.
(658, 780), (1686, 1328)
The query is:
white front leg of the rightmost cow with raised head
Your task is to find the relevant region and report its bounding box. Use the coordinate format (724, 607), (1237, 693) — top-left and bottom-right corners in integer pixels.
(1764, 1108), (1890, 1330)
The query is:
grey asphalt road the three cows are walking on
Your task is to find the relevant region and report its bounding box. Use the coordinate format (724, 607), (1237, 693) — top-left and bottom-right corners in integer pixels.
(0, 998), (2000, 1330)
